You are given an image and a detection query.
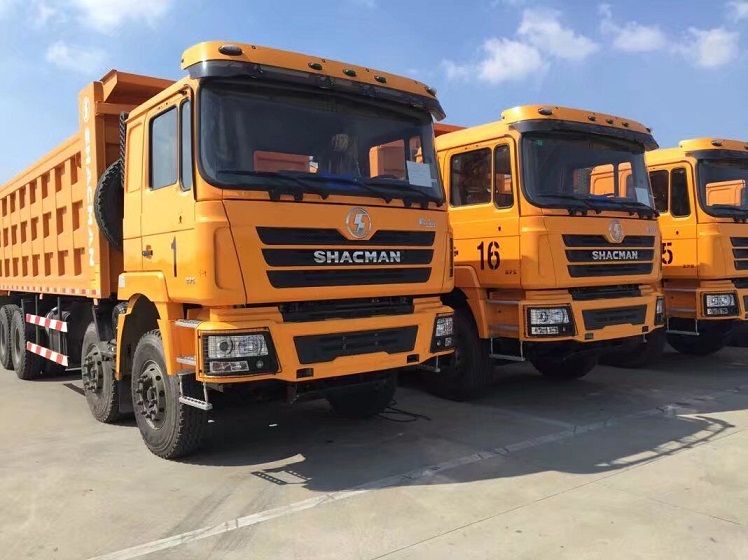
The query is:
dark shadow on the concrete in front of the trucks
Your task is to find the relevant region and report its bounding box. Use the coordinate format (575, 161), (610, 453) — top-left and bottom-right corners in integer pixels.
(177, 349), (748, 492)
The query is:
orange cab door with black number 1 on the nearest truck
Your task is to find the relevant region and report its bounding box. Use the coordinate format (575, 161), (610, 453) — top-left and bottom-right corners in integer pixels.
(141, 91), (197, 300)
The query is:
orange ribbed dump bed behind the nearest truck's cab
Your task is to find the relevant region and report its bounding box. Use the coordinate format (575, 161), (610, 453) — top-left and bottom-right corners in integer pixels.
(0, 70), (173, 298)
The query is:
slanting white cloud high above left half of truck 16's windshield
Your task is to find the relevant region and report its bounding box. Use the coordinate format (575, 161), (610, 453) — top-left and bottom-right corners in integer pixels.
(517, 9), (598, 60)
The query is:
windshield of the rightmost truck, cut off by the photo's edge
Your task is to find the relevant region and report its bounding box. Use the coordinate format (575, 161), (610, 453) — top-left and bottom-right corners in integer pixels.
(698, 158), (748, 217)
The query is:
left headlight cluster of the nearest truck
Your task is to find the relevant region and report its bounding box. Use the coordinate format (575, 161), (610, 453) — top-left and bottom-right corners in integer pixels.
(205, 332), (278, 375)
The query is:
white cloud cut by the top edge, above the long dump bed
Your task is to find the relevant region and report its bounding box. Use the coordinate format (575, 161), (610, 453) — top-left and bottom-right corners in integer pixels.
(67, 0), (173, 33)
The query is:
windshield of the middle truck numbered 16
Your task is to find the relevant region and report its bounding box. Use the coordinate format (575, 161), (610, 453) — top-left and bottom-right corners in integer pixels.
(522, 132), (654, 213)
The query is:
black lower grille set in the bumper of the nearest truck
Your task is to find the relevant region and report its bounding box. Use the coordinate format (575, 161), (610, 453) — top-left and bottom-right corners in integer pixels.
(294, 326), (418, 364)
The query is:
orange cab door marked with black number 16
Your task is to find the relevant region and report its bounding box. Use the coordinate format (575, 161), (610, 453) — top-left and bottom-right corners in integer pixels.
(444, 138), (520, 287)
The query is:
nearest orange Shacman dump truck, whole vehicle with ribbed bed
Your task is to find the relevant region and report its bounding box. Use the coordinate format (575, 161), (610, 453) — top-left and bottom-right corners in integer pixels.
(0, 43), (453, 458)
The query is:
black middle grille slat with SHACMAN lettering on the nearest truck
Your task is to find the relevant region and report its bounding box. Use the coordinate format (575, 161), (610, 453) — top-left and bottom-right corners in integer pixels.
(262, 249), (434, 266)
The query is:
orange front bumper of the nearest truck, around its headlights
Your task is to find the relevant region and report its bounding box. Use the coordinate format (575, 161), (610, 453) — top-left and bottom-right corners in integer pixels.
(181, 298), (452, 383)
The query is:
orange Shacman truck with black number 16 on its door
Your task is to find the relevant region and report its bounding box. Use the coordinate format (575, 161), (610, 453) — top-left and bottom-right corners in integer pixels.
(433, 106), (664, 398)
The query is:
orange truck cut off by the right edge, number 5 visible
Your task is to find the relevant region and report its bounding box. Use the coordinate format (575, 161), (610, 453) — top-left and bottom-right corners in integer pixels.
(647, 138), (748, 355)
